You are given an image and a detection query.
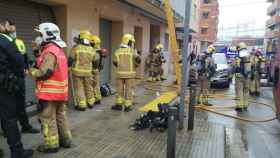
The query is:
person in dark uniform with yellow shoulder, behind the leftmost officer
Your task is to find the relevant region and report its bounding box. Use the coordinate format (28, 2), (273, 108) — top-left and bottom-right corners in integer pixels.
(1, 20), (40, 135)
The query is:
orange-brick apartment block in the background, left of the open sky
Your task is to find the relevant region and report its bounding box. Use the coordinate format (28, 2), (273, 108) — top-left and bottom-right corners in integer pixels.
(199, 0), (219, 51)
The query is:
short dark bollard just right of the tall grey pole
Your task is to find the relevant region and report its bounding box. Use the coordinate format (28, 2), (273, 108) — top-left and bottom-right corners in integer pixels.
(188, 84), (196, 131)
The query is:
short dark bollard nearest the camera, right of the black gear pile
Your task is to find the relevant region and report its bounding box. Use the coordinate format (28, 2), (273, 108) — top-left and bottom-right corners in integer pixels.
(167, 106), (178, 158)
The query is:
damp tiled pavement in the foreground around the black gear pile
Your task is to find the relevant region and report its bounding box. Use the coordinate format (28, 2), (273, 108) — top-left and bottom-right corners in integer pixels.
(0, 82), (225, 158)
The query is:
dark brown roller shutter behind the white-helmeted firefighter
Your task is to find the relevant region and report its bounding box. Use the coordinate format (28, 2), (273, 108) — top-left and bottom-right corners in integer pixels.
(0, 0), (55, 105)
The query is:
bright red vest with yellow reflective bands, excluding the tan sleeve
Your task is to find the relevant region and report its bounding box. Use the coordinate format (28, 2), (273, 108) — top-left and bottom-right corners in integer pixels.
(36, 43), (68, 101)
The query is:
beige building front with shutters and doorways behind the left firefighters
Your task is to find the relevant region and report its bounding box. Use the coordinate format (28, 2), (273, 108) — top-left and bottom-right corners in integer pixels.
(0, 0), (188, 103)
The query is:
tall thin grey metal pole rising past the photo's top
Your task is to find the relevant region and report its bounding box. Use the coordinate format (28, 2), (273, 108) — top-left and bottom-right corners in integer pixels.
(179, 0), (192, 129)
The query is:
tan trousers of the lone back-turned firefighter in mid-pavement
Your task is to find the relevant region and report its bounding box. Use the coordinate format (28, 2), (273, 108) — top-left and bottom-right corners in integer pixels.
(116, 78), (134, 107)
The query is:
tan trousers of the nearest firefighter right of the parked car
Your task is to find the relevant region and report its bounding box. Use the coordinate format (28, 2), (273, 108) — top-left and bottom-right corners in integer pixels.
(235, 75), (249, 108)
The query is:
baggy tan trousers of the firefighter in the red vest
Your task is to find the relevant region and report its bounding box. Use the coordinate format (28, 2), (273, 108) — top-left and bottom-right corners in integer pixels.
(39, 101), (72, 148)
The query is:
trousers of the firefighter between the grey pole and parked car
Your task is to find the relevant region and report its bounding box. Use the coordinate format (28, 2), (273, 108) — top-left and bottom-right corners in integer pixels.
(196, 75), (209, 104)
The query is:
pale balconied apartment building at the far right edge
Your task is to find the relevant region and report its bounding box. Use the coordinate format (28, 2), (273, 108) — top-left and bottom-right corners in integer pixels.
(265, 0), (280, 54)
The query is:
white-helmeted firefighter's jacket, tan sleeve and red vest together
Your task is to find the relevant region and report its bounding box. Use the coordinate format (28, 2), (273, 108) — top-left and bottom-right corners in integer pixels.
(31, 43), (68, 101)
